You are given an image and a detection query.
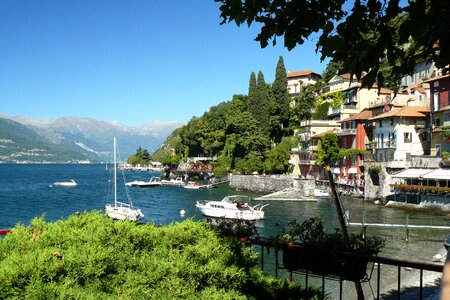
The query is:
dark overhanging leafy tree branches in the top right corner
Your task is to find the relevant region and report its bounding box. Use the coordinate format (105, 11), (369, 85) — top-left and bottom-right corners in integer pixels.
(215, 0), (450, 87)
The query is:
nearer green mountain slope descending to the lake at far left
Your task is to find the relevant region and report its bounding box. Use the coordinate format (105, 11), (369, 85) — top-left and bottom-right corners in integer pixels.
(0, 118), (88, 163)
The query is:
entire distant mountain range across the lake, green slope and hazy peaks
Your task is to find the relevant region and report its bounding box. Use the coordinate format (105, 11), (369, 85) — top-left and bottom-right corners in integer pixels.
(0, 115), (182, 163)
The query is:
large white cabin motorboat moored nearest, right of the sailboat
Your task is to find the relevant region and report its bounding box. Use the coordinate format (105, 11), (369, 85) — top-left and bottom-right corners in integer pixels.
(195, 195), (269, 220)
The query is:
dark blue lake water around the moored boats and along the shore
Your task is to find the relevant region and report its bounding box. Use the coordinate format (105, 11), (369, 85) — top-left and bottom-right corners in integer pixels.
(0, 164), (450, 261)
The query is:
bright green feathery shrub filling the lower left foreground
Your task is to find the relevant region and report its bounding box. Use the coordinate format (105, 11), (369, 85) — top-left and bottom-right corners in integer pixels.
(0, 212), (320, 299)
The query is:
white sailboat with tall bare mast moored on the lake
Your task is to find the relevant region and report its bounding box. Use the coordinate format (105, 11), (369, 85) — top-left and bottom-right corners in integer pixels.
(105, 138), (144, 221)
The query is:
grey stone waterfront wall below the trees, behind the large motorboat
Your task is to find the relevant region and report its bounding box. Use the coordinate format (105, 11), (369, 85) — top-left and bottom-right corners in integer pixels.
(230, 175), (294, 193)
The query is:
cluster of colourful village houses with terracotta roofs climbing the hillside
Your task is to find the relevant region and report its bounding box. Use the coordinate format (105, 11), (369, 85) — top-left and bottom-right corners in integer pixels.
(288, 62), (450, 203)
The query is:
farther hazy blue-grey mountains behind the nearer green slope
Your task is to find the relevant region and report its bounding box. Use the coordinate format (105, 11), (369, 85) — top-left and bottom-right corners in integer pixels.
(0, 116), (182, 161)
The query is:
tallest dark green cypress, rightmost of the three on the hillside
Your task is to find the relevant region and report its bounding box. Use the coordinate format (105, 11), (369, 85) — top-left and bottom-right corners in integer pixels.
(272, 56), (291, 127)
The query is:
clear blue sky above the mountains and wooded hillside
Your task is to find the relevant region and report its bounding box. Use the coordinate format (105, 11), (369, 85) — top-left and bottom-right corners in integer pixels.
(0, 0), (326, 126)
